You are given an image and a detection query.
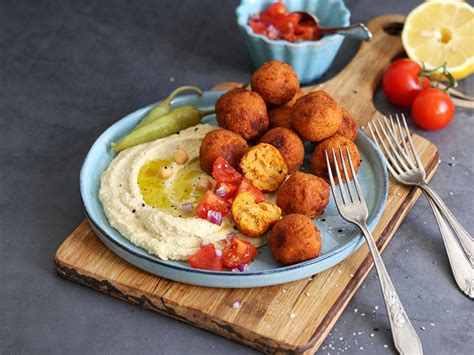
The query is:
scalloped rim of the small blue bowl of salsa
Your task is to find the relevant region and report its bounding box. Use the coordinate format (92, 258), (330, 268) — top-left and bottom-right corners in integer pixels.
(235, 1), (351, 48)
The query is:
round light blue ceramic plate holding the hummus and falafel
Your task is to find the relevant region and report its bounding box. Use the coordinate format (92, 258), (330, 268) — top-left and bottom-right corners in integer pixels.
(80, 91), (388, 288)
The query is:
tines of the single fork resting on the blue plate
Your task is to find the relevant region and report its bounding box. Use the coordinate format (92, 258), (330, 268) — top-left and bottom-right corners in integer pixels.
(325, 146), (365, 208)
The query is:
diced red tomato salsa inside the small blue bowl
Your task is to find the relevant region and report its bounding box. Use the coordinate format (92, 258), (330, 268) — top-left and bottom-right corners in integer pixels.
(248, 0), (322, 42)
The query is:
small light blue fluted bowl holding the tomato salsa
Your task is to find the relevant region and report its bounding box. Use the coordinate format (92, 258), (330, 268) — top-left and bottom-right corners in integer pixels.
(236, 0), (351, 84)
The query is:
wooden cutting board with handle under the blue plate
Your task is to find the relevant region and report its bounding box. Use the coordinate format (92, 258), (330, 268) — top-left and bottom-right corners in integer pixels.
(55, 15), (439, 353)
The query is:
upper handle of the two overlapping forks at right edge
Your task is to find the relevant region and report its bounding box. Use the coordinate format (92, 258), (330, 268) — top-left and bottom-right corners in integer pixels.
(418, 183), (474, 268)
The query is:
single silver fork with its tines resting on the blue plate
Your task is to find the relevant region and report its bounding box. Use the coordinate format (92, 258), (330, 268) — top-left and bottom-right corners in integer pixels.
(326, 147), (423, 355)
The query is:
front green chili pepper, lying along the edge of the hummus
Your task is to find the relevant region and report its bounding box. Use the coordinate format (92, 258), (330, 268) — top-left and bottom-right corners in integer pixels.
(112, 105), (214, 153)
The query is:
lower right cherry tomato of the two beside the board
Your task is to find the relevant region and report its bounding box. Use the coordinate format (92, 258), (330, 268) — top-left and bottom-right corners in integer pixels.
(411, 88), (454, 131)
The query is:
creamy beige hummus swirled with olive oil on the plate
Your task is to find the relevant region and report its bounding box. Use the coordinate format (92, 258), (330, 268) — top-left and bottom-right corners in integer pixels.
(99, 124), (267, 260)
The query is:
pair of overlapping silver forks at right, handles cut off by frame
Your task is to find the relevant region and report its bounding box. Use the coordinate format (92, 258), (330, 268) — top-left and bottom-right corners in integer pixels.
(369, 114), (474, 298)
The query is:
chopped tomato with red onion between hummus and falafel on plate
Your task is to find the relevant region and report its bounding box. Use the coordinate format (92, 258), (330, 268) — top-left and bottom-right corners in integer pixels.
(188, 157), (265, 272)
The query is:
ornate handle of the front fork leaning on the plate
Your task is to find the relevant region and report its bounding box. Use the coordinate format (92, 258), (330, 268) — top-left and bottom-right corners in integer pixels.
(359, 223), (423, 355)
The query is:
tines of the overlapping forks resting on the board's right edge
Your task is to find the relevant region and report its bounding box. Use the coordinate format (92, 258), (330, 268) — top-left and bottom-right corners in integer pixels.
(368, 113), (425, 176)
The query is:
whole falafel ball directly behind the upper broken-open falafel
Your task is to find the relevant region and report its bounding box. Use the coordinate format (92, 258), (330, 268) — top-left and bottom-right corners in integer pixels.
(260, 127), (304, 174)
